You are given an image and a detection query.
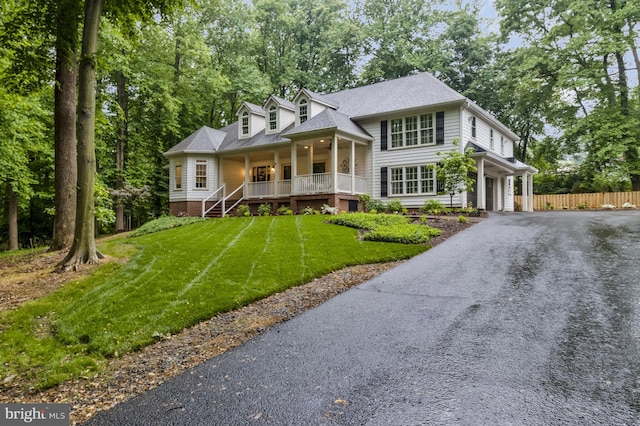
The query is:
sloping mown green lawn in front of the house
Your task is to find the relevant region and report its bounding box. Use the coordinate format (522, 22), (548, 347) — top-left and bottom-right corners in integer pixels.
(0, 216), (428, 388)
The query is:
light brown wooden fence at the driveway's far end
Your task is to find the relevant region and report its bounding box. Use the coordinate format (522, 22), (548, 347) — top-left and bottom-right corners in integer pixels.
(514, 191), (640, 210)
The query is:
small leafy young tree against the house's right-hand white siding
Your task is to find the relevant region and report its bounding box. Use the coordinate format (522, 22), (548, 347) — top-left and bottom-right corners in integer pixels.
(436, 139), (478, 208)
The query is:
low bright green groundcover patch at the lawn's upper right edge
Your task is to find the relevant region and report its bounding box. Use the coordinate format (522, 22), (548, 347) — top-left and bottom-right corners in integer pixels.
(329, 213), (440, 244)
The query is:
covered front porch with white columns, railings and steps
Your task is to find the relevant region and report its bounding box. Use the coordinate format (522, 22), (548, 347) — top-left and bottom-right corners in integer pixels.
(201, 134), (369, 216)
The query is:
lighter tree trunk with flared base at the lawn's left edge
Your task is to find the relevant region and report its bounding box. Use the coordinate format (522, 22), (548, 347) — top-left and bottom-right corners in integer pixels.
(61, 0), (104, 269)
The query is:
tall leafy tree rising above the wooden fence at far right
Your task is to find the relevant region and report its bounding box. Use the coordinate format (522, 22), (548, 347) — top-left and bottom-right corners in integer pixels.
(496, 0), (640, 190)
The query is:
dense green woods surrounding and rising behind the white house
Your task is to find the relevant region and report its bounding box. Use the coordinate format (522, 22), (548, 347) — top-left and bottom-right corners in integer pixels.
(0, 0), (640, 249)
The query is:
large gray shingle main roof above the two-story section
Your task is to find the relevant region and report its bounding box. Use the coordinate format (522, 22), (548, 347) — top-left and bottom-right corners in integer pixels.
(322, 72), (467, 119)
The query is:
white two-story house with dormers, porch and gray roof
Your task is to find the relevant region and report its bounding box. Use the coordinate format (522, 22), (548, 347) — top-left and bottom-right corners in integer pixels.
(164, 73), (537, 216)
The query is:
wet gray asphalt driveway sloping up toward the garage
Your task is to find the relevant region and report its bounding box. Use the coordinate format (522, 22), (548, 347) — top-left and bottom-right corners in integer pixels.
(88, 211), (640, 426)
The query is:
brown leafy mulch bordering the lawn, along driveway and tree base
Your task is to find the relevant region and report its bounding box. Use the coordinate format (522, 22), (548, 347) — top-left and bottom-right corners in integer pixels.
(0, 217), (481, 424)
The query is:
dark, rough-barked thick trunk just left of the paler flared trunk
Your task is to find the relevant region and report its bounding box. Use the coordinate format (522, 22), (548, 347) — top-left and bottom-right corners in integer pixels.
(50, 8), (78, 250)
